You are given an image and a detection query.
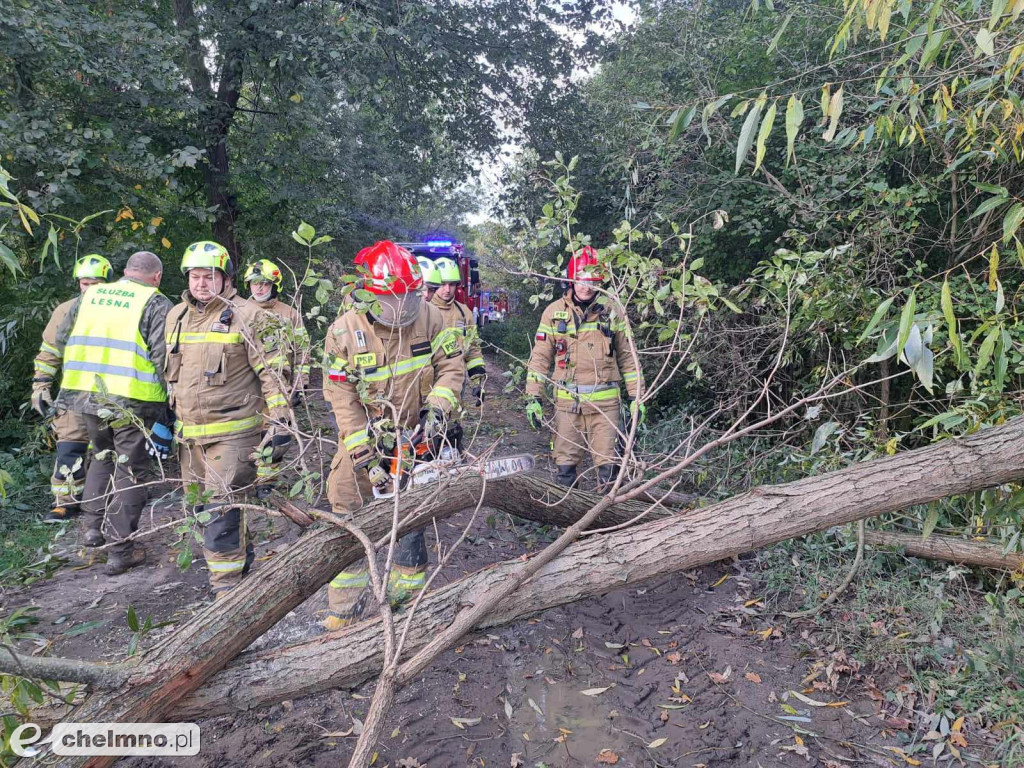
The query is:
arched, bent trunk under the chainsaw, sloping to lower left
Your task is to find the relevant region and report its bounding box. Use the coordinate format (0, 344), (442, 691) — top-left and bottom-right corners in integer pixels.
(46, 473), (649, 768)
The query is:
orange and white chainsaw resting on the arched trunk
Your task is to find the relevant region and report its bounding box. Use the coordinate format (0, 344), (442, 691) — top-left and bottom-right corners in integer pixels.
(374, 430), (534, 499)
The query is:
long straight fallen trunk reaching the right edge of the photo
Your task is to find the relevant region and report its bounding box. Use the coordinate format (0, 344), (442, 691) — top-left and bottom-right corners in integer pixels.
(178, 419), (1024, 719)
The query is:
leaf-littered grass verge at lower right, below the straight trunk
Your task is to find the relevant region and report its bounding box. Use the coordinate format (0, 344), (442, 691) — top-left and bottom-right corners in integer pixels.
(757, 534), (1024, 766)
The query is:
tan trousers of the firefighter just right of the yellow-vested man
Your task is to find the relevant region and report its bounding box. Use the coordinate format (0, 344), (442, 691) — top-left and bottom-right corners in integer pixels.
(178, 432), (260, 594)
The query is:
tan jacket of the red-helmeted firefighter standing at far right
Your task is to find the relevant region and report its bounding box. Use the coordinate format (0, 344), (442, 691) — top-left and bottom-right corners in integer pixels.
(526, 294), (640, 410)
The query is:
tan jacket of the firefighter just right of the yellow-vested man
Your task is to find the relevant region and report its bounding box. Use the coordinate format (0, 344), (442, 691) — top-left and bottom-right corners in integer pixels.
(165, 286), (291, 443)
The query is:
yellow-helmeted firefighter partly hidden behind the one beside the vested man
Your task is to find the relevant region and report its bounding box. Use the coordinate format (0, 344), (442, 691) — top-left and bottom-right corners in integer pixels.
(245, 259), (309, 487)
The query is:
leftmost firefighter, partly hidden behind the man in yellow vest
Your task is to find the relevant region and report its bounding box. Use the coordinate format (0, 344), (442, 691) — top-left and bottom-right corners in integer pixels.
(32, 253), (113, 523)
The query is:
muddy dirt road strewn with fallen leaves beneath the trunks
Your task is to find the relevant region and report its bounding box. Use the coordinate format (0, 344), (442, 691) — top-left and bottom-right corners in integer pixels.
(6, 358), (905, 768)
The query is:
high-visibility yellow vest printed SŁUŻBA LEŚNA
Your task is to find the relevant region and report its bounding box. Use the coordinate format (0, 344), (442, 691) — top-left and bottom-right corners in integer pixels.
(60, 281), (167, 402)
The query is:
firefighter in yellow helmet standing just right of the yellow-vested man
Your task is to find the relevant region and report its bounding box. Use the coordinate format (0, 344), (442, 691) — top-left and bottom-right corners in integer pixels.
(166, 242), (291, 599)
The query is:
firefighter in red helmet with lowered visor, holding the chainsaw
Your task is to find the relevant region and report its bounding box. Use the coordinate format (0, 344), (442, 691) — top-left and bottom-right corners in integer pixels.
(324, 241), (466, 630)
